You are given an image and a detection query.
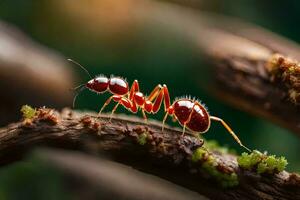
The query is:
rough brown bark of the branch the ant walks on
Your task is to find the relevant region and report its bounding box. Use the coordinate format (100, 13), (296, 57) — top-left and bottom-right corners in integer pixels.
(0, 109), (300, 199)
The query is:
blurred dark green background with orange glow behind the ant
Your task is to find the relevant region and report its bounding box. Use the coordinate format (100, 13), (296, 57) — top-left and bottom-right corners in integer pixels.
(0, 0), (300, 199)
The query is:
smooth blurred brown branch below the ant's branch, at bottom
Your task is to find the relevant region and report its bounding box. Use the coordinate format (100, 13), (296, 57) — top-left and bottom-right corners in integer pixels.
(33, 149), (208, 200)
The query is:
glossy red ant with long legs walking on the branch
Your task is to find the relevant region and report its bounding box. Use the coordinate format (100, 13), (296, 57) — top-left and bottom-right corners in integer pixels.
(68, 59), (251, 152)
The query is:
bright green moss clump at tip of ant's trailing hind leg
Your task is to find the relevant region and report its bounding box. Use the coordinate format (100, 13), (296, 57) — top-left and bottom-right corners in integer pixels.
(237, 150), (288, 174)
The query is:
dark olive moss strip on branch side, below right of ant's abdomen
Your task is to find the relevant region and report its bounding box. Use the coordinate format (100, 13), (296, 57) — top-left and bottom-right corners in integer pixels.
(192, 147), (239, 188)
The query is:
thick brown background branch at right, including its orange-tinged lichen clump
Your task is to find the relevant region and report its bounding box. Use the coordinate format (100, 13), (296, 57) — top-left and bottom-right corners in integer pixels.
(211, 46), (300, 135)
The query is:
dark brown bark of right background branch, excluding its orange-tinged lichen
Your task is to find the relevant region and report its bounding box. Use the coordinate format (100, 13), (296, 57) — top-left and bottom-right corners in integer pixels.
(214, 55), (300, 135)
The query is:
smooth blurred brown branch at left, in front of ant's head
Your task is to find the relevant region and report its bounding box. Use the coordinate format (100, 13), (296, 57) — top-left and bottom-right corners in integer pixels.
(0, 21), (74, 125)
